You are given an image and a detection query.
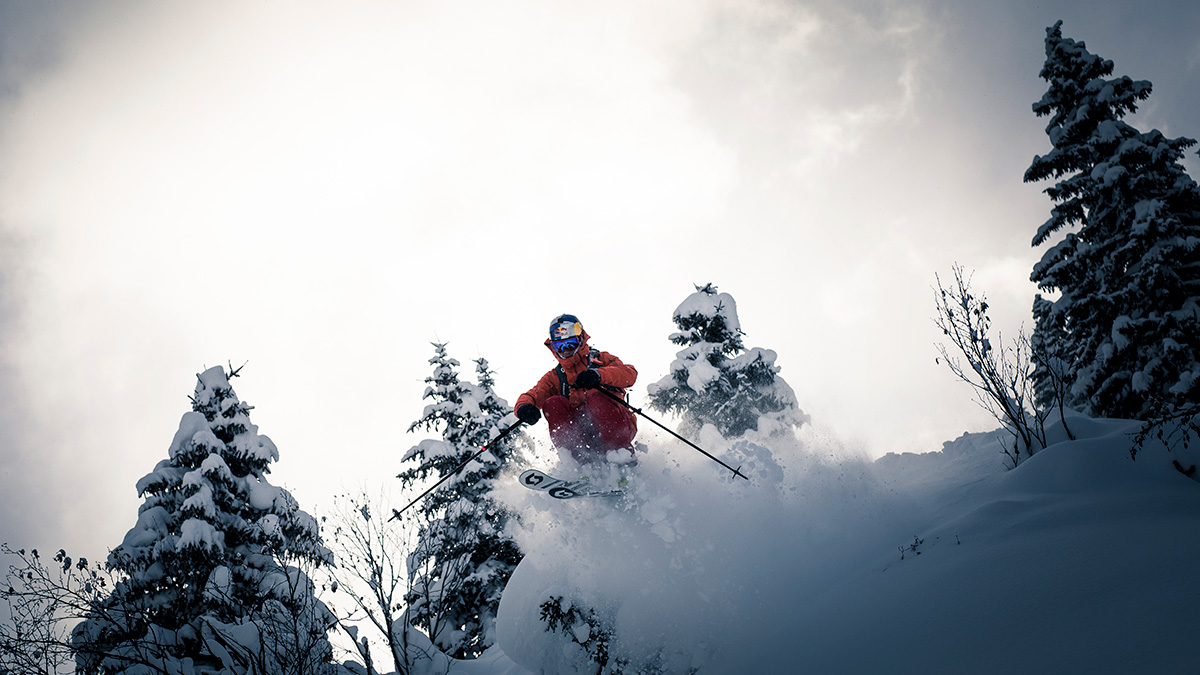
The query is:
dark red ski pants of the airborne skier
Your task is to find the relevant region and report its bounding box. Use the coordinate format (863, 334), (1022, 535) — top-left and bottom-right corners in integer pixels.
(541, 394), (637, 462)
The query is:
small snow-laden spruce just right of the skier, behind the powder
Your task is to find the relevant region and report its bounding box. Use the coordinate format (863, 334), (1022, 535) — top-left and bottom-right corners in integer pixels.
(647, 283), (808, 438)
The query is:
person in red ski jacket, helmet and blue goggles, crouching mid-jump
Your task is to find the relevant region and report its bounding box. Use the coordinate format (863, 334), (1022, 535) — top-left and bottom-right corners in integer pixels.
(516, 313), (637, 465)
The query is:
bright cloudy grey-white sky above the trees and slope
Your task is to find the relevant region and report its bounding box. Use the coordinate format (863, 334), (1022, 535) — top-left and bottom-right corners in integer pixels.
(0, 0), (1200, 556)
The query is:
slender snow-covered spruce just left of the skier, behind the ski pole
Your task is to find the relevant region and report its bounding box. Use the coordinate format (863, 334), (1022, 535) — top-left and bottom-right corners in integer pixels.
(398, 344), (521, 658)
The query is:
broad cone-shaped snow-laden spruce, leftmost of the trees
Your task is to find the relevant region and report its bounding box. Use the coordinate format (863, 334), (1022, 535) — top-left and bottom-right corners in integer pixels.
(72, 368), (332, 675)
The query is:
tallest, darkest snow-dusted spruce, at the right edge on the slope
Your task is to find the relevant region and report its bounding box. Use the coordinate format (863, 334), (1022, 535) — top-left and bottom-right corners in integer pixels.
(1025, 22), (1200, 419)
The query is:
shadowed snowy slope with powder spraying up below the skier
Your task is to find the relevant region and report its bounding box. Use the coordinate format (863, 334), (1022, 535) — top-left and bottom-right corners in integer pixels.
(429, 417), (1200, 675)
